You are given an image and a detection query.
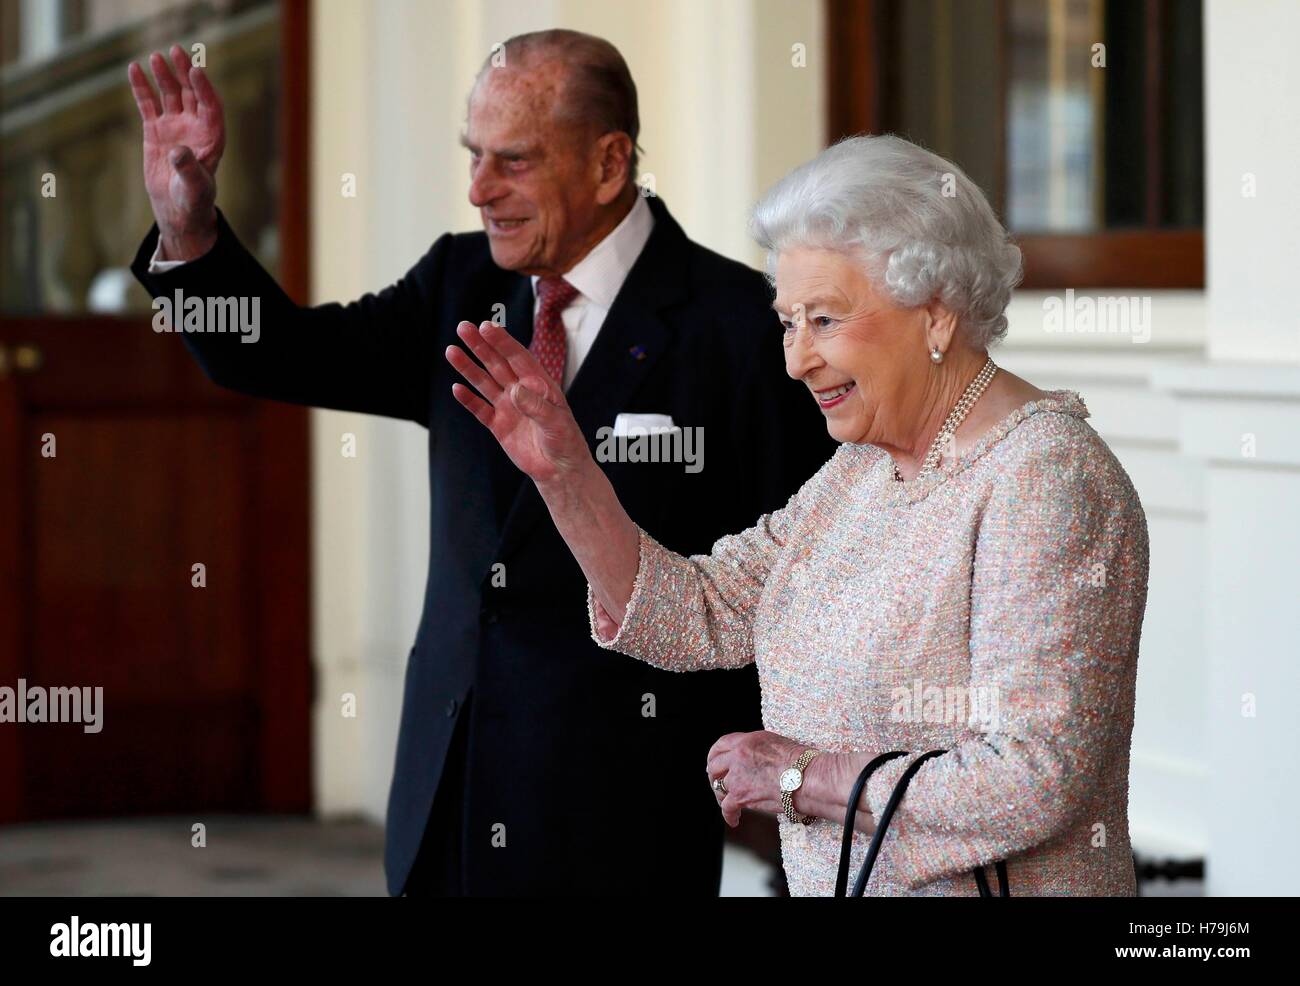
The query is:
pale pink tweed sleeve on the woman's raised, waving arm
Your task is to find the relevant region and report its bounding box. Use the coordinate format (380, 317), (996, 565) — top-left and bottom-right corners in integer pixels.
(586, 463), (829, 671)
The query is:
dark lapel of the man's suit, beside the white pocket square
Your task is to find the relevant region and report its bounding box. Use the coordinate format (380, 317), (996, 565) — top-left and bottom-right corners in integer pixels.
(497, 198), (689, 559)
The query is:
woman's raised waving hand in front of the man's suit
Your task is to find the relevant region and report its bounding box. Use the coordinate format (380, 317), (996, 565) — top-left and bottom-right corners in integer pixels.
(447, 321), (592, 485)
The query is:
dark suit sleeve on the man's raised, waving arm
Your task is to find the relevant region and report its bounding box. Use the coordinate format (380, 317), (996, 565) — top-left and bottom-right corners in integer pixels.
(131, 209), (441, 425)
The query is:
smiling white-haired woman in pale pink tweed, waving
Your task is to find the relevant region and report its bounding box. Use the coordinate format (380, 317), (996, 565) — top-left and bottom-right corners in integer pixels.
(447, 137), (1148, 896)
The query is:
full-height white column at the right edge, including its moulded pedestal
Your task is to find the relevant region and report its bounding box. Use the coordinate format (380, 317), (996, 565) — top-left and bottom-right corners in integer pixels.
(1153, 0), (1300, 896)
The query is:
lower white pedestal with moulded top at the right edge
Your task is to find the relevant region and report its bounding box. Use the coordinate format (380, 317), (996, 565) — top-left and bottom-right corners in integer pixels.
(1153, 363), (1300, 896)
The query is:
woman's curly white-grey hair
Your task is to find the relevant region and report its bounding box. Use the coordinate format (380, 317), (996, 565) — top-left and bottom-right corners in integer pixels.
(750, 134), (1022, 349)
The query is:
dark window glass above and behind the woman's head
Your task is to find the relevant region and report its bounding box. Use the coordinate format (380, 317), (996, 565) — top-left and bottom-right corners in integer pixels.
(881, 0), (1204, 233)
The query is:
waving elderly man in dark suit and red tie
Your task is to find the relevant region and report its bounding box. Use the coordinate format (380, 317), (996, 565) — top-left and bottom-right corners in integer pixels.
(129, 30), (833, 895)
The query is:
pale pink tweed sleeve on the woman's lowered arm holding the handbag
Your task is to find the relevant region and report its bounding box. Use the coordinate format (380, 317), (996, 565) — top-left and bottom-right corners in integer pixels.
(867, 444), (1148, 894)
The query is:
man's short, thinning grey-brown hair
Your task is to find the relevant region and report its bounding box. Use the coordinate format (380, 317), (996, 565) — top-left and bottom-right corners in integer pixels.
(475, 27), (641, 182)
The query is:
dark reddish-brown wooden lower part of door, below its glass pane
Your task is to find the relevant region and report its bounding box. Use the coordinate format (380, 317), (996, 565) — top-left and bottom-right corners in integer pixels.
(0, 319), (311, 821)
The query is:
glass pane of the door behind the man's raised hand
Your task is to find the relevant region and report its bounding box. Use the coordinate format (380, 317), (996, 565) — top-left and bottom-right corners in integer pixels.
(0, 0), (280, 313)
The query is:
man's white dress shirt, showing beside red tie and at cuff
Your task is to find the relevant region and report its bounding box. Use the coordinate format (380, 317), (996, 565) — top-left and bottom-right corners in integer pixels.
(150, 195), (654, 390)
